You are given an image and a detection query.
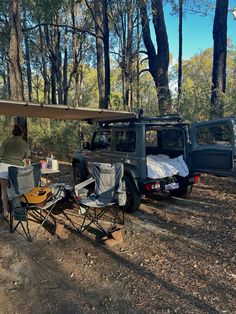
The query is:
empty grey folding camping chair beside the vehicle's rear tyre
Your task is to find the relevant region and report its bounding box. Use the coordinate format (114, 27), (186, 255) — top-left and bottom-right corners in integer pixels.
(75, 163), (126, 236)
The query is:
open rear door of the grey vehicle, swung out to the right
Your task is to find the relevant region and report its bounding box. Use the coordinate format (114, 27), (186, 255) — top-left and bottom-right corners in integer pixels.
(190, 117), (236, 176)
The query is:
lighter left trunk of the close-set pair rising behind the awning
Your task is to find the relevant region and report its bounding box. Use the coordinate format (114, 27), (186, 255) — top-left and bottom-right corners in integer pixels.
(94, 0), (106, 108)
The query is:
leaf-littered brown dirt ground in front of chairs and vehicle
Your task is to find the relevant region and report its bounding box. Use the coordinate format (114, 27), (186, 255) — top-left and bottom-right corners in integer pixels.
(0, 165), (236, 314)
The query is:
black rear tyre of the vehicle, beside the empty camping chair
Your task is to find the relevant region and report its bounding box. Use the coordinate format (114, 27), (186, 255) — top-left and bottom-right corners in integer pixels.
(124, 176), (141, 213)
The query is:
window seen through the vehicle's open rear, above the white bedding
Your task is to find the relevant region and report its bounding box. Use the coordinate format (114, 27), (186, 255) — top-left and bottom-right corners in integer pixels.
(161, 129), (184, 149)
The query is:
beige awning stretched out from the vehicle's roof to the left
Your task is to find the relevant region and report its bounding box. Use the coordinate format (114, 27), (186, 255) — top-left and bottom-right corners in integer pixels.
(0, 100), (136, 122)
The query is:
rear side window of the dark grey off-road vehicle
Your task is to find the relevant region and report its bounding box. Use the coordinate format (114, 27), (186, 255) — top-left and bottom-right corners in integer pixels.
(115, 131), (136, 153)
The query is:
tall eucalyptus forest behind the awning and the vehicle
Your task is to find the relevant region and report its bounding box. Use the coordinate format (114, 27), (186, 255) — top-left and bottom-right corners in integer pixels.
(0, 0), (236, 159)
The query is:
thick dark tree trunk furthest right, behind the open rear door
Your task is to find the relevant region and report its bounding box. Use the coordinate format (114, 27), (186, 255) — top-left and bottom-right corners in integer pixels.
(210, 0), (229, 118)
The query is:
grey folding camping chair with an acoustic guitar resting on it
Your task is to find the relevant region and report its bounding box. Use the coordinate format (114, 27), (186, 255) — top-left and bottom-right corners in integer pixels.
(8, 163), (64, 241)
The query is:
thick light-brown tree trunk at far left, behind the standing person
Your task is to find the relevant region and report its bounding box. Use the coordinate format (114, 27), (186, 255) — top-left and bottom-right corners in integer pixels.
(9, 0), (27, 140)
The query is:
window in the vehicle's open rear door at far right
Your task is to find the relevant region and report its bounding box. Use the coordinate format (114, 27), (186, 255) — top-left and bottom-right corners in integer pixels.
(196, 123), (232, 146)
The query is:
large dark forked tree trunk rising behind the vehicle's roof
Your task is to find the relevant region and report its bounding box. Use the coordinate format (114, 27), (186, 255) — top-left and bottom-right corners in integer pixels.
(140, 0), (172, 115)
